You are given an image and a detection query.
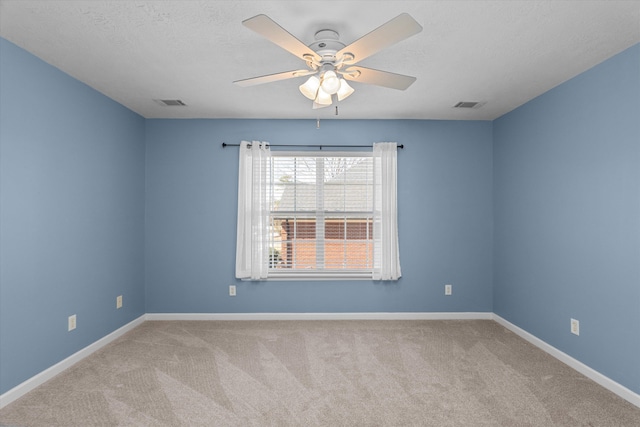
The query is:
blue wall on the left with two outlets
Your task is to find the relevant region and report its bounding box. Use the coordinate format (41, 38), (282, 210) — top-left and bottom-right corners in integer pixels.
(0, 39), (144, 393)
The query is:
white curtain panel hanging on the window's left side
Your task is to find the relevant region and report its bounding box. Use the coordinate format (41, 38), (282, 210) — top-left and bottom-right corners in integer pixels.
(236, 141), (271, 280)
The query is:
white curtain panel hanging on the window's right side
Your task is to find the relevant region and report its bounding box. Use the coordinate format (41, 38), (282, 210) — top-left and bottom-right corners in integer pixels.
(373, 142), (402, 280)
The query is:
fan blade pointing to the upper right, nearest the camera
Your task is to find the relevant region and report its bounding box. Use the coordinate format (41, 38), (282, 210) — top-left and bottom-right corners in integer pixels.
(336, 13), (422, 64)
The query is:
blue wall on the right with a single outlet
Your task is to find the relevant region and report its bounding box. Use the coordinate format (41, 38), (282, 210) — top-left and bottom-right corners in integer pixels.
(494, 45), (640, 393)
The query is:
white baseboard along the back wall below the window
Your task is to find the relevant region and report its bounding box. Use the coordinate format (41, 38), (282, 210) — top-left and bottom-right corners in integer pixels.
(146, 312), (493, 320)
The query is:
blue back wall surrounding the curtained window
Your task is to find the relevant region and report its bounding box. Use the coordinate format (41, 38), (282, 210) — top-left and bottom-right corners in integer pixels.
(145, 120), (493, 313)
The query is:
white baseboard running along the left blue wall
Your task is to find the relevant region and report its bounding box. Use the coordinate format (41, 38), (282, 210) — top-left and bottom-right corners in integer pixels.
(0, 314), (145, 409)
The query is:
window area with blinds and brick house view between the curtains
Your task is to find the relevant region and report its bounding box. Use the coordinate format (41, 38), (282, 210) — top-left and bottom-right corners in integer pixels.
(268, 152), (373, 278)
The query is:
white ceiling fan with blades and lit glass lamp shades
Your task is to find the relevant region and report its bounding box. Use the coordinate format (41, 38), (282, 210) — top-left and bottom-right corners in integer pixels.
(234, 13), (422, 109)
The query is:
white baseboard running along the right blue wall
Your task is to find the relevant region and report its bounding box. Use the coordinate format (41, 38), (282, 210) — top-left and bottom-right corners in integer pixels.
(493, 313), (640, 408)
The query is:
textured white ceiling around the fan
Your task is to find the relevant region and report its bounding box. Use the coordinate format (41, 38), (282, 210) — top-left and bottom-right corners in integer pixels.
(0, 0), (640, 120)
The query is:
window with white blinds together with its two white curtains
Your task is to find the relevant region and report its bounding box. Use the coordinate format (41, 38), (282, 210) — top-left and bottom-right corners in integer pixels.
(236, 141), (401, 280)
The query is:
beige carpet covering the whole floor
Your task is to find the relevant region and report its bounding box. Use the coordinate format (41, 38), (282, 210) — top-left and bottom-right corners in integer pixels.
(0, 320), (640, 427)
